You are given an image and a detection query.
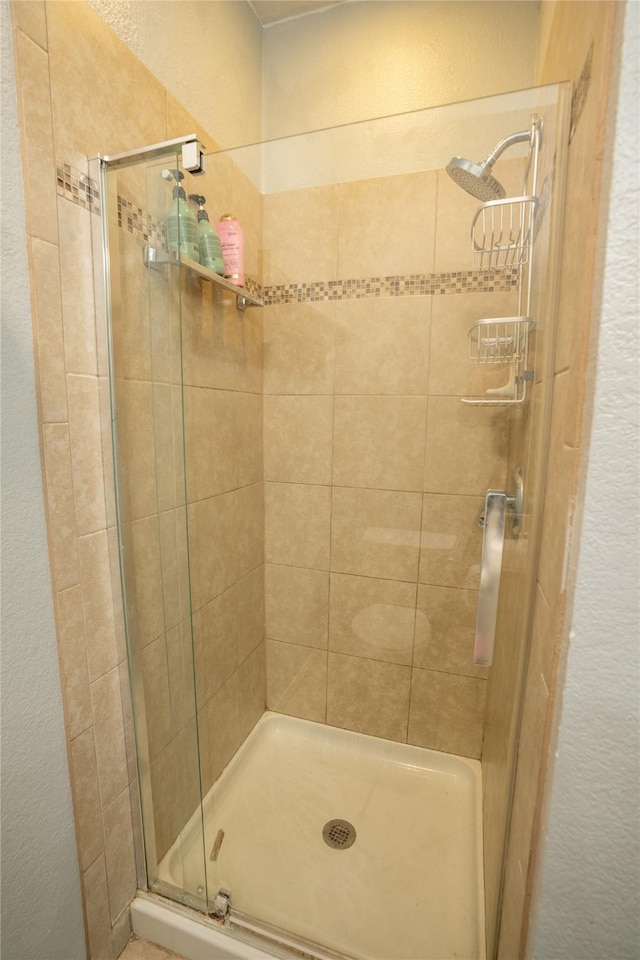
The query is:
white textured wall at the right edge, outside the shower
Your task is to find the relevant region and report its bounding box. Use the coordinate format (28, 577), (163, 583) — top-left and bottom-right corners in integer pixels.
(532, 3), (640, 960)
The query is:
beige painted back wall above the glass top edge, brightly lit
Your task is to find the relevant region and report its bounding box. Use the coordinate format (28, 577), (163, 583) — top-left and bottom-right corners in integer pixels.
(263, 0), (539, 139)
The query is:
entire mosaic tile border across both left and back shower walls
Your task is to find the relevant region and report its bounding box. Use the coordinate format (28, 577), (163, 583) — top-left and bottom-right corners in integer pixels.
(56, 161), (518, 306)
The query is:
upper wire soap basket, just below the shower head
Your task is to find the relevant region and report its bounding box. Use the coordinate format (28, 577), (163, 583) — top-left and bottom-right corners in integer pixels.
(471, 196), (538, 270)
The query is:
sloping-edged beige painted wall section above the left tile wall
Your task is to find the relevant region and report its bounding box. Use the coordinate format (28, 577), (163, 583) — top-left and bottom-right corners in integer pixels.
(88, 0), (262, 147)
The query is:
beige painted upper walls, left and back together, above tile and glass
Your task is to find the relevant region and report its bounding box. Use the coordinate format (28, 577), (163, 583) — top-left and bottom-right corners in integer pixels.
(88, 0), (539, 147)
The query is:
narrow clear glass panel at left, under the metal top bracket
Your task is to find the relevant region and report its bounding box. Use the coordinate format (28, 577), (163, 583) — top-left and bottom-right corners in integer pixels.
(106, 155), (206, 908)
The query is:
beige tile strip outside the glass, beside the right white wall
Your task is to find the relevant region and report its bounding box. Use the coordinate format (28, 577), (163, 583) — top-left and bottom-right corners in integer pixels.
(498, 2), (622, 960)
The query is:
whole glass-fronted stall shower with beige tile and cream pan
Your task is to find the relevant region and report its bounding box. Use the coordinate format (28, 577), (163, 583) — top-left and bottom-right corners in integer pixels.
(93, 86), (567, 960)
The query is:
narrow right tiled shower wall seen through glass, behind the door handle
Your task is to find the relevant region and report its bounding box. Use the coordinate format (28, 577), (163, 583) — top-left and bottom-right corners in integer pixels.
(482, 84), (571, 950)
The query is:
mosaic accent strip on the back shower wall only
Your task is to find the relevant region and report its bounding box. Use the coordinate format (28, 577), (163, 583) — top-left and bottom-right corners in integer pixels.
(263, 269), (518, 306)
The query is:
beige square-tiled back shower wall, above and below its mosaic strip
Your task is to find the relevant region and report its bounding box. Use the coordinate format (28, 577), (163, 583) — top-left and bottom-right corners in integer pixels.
(264, 167), (519, 757)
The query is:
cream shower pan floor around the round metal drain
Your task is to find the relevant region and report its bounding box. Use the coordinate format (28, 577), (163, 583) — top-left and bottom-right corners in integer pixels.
(161, 713), (484, 960)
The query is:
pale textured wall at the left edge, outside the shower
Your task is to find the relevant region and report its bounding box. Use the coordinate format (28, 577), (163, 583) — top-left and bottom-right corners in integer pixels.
(0, 0), (85, 960)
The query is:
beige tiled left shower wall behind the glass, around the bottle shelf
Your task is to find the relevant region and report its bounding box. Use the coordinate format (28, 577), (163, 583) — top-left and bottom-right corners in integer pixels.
(103, 58), (265, 895)
